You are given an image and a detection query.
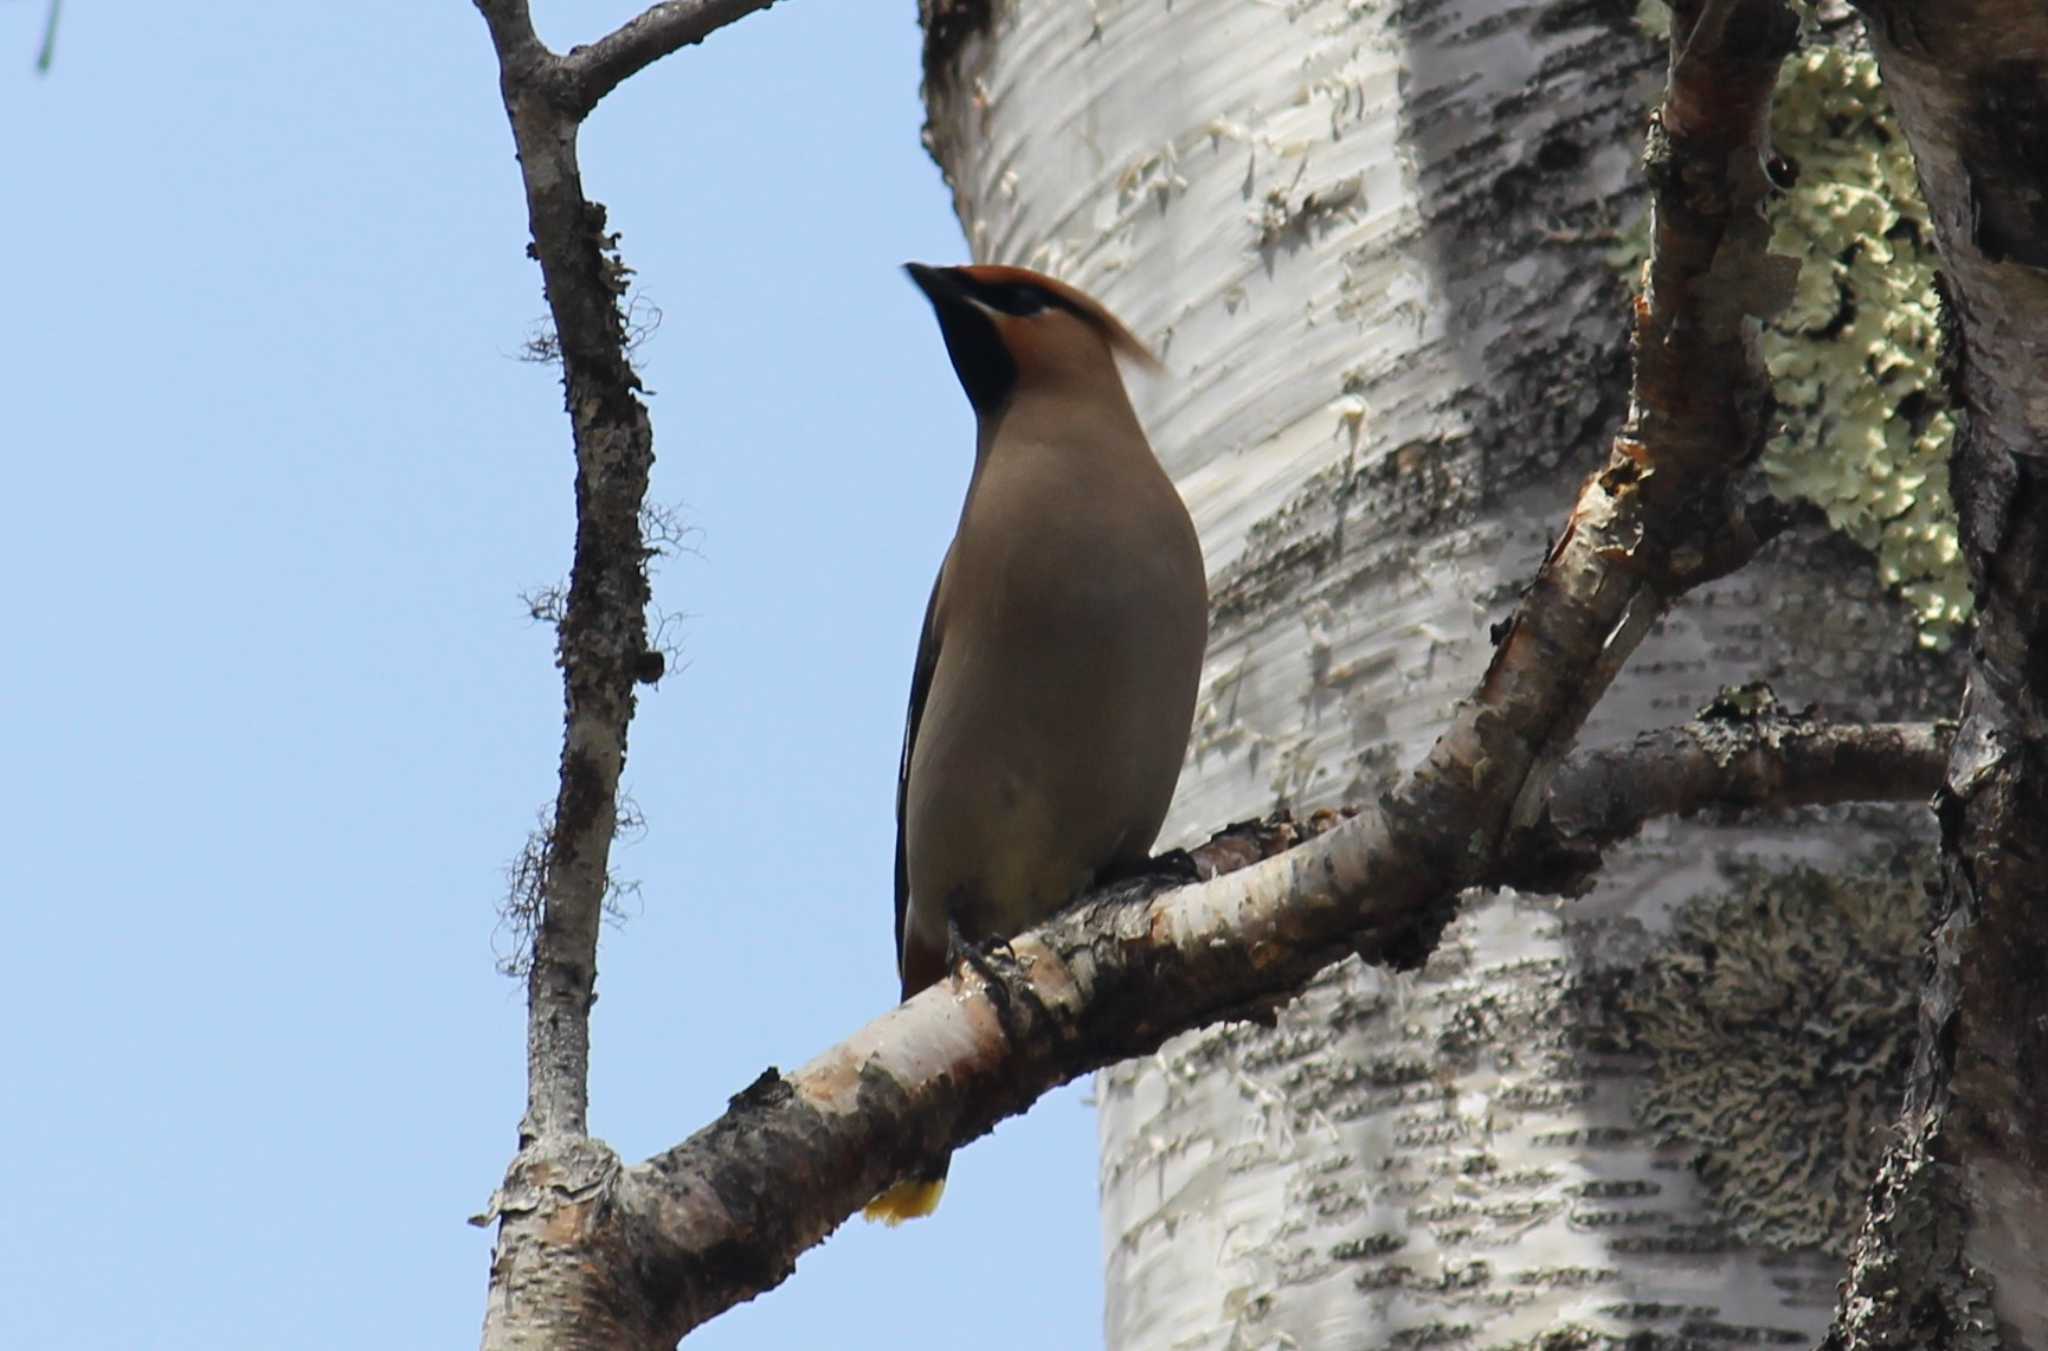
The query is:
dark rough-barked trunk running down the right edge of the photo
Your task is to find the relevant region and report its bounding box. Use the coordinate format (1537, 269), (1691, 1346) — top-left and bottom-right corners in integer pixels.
(1831, 0), (2048, 1349)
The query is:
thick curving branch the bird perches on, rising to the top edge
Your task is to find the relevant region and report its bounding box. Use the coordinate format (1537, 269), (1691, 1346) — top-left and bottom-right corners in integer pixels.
(479, 0), (1798, 1347)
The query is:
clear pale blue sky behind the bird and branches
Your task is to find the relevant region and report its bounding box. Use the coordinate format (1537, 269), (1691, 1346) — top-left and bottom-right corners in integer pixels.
(0, 0), (1100, 1351)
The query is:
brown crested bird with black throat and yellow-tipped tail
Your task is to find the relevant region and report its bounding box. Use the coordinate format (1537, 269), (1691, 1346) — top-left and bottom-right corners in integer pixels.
(864, 262), (1208, 1224)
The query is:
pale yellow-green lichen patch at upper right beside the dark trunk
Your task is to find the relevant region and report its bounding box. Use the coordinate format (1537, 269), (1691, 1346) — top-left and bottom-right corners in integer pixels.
(1763, 47), (1970, 649)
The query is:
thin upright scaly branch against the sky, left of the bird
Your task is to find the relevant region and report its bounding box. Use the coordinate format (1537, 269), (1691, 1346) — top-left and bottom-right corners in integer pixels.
(477, 0), (659, 1347)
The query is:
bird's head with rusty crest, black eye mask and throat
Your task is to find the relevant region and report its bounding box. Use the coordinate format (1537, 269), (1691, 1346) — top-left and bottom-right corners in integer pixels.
(903, 262), (1159, 418)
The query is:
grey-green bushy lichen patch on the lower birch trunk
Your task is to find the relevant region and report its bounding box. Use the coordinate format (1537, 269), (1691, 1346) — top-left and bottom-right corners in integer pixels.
(1618, 858), (1929, 1255)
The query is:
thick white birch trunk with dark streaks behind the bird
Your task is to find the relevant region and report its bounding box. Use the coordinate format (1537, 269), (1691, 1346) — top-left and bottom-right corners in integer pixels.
(922, 0), (1956, 1351)
